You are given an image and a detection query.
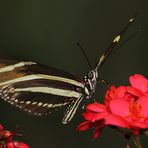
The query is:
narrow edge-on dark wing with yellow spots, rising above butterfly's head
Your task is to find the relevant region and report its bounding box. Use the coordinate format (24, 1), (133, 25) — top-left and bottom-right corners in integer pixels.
(94, 13), (138, 71)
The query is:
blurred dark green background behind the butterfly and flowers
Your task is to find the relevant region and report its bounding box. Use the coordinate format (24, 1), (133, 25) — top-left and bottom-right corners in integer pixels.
(0, 0), (148, 148)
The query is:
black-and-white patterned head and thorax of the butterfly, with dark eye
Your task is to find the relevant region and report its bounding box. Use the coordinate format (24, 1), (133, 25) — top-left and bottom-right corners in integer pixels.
(84, 70), (98, 98)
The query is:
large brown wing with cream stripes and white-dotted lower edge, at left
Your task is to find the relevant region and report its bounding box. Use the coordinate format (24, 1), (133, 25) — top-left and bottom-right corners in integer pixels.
(0, 58), (84, 116)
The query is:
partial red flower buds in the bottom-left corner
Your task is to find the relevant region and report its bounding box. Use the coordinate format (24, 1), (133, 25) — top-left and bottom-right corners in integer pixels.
(0, 125), (29, 148)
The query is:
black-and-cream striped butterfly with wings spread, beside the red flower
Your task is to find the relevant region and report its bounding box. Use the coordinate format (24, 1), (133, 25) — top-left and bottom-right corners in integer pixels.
(0, 15), (135, 124)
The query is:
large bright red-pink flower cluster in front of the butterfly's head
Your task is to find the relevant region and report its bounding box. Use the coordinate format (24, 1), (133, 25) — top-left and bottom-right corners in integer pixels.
(78, 74), (148, 138)
